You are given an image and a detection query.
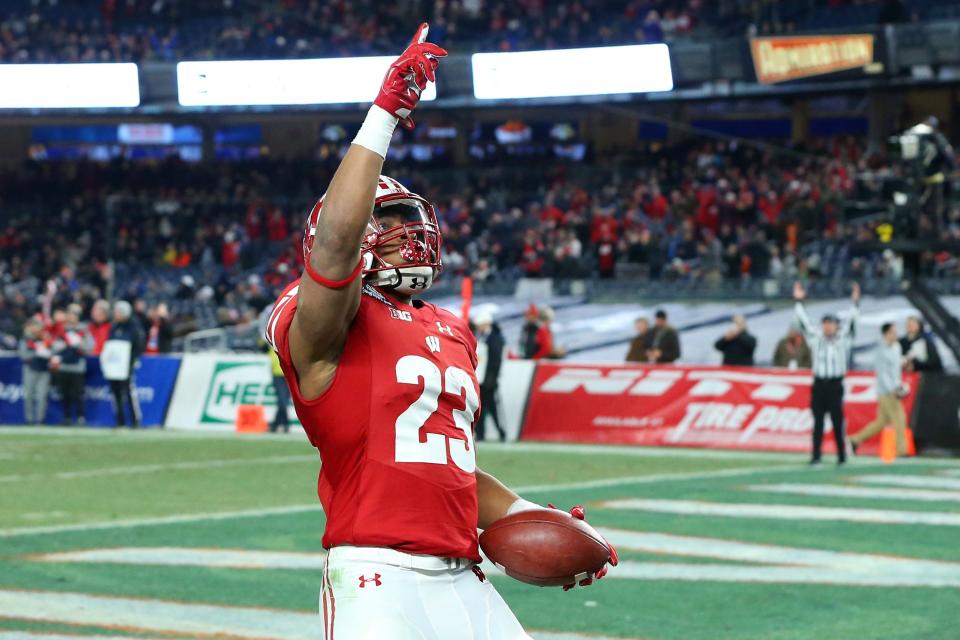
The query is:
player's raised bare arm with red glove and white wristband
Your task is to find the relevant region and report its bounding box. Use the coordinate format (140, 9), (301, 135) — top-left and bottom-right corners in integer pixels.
(289, 23), (446, 398)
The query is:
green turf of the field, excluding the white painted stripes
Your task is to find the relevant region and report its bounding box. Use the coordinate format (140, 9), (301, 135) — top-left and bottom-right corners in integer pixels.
(0, 429), (960, 640)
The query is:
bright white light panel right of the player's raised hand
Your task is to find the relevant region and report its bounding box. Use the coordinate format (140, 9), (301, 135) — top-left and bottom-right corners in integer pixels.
(472, 44), (673, 100)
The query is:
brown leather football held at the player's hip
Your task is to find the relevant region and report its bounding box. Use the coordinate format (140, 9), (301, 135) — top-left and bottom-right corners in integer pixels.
(480, 509), (610, 587)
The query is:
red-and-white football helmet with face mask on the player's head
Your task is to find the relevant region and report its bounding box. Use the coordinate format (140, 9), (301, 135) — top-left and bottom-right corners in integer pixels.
(303, 176), (443, 294)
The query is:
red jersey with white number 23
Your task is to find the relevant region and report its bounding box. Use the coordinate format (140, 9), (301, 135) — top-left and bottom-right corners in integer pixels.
(266, 280), (480, 561)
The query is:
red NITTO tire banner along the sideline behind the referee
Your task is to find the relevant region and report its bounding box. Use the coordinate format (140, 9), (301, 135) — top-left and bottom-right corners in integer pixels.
(521, 363), (919, 453)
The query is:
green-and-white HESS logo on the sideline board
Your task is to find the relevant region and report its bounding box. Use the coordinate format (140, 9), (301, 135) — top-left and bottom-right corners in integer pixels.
(201, 361), (286, 423)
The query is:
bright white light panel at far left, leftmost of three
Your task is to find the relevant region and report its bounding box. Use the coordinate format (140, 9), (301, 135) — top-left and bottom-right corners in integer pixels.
(0, 62), (140, 109)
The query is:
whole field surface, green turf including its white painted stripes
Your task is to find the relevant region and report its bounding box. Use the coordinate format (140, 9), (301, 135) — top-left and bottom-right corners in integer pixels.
(0, 428), (960, 640)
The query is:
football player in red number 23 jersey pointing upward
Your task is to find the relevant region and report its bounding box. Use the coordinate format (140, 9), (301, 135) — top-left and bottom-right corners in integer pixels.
(266, 24), (616, 640)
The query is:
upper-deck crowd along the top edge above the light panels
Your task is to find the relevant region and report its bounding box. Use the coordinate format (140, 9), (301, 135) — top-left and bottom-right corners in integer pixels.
(0, 0), (925, 62)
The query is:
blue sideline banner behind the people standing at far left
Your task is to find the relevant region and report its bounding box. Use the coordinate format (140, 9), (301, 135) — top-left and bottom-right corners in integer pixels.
(0, 356), (180, 427)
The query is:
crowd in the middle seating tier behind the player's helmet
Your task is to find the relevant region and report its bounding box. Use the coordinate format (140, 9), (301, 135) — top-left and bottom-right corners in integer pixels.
(0, 132), (960, 348)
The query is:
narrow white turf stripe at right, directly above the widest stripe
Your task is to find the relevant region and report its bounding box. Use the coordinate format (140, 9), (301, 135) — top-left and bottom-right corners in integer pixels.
(596, 499), (960, 527)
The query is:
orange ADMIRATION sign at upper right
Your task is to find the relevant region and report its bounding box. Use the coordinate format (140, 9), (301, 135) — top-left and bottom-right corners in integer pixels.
(750, 34), (874, 84)
